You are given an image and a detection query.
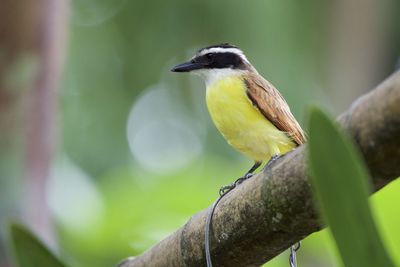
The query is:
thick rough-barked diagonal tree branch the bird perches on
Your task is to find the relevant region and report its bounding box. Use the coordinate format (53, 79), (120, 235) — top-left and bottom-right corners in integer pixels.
(119, 72), (400, 267)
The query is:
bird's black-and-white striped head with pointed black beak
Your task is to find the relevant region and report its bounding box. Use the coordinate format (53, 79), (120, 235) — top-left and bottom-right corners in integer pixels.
(171, 43), (253, 83)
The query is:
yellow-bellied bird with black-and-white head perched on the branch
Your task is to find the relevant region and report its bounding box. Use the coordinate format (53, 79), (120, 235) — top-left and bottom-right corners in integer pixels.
(171, 44), (306, 178)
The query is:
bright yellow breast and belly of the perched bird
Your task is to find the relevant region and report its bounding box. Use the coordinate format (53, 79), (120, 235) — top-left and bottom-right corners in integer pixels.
(206, 75), (296, 162)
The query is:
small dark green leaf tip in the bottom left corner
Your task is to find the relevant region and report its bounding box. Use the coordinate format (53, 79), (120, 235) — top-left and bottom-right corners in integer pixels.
(10, 224), (66, 267)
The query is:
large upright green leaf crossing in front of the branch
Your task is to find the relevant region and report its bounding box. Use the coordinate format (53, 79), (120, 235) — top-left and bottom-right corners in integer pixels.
(309, 109), (394, 267)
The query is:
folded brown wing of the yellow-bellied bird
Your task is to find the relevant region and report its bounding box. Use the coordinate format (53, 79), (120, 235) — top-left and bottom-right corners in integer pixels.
(244, 73), (306, 145)
